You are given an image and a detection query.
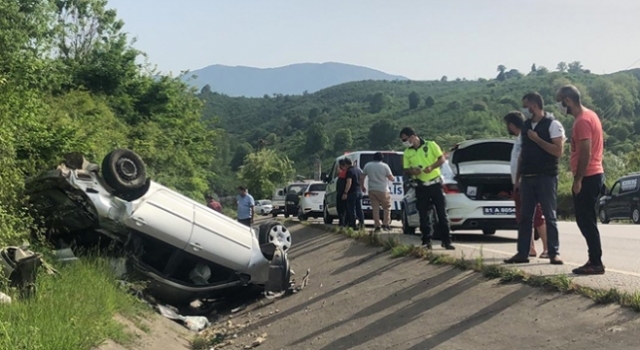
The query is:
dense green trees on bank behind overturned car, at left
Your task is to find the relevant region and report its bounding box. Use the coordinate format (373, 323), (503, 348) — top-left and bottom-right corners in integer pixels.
(0, 0), (254, 243)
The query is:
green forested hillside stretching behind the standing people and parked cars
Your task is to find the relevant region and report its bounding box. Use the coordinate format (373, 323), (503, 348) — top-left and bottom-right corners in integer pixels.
(199, 62), (640, 216)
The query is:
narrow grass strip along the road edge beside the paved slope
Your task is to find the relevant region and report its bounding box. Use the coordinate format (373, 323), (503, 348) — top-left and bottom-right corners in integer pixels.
(316, 221), (640, 312)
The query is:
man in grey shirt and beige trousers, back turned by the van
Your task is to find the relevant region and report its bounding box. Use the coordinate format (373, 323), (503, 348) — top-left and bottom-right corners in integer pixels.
(360, 152), (394, 232)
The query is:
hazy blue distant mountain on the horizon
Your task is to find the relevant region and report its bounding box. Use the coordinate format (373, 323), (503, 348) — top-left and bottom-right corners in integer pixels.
(185, 62), (408, 97)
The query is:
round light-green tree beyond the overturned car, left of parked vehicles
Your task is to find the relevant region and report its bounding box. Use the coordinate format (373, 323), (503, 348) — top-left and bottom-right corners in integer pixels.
(238, 149), (295, 199)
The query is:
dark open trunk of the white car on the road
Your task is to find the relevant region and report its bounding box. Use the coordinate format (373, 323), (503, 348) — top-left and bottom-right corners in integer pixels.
(451, 141), (513, 200)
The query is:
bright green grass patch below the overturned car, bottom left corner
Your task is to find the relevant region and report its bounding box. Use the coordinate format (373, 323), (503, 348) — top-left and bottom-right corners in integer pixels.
(0, 257), (150, 350)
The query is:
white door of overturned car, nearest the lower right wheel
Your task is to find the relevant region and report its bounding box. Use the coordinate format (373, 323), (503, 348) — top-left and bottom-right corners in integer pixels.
(185, 204), (253, 271)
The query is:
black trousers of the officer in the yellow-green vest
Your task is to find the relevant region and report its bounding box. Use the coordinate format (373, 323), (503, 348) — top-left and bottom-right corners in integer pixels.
(416, 183), (451, 244)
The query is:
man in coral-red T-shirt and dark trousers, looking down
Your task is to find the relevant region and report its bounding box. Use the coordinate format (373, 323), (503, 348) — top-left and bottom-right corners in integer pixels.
(556, 85), (604, 275)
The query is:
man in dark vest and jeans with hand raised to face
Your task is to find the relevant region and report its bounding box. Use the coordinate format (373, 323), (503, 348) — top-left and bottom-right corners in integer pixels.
(504, 92), (565, 265)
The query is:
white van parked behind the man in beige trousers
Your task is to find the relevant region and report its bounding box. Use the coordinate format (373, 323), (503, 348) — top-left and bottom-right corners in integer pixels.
(322, 151), (404, 224)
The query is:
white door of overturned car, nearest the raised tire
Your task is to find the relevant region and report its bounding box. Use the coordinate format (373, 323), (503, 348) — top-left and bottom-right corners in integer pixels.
(125, 188), (195, 249)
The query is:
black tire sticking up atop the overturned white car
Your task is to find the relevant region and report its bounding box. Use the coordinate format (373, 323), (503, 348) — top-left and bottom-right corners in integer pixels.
(101, 149), (147, 194)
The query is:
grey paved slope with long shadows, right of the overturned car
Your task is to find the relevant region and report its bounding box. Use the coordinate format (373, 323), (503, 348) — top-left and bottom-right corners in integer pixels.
(222, 223), (640, 350)
